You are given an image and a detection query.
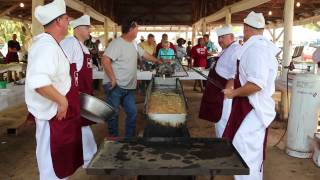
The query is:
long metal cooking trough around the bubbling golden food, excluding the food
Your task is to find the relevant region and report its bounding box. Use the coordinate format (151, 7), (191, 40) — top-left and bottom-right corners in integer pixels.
(144, 77), (188, 125)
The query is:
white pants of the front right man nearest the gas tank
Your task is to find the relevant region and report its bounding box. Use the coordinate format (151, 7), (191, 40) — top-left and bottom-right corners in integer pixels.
(232, 110), (266, 180)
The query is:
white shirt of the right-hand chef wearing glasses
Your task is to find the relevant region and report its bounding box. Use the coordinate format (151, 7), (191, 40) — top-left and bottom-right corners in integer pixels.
(216, 42), (241, 79)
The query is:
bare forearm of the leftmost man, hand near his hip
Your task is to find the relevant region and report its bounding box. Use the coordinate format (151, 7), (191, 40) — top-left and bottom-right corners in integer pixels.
(36, 85), (65, 105)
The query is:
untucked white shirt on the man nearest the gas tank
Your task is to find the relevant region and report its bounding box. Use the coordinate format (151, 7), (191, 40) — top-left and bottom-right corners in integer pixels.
(237, 35), (280, 127)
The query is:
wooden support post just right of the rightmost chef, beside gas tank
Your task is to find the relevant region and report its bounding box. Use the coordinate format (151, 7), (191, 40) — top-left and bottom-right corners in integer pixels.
(281, 0), (294, 119)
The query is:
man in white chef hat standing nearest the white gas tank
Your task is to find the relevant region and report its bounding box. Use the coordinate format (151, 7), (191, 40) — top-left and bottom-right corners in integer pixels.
(222, 12), (280, 180)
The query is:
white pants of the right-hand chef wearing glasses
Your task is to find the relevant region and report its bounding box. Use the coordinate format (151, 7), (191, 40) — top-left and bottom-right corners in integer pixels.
(215, 99), (232, 138)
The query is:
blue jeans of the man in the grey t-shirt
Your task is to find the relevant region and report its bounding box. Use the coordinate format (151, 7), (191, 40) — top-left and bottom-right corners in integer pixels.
(103, 83), (137, 137)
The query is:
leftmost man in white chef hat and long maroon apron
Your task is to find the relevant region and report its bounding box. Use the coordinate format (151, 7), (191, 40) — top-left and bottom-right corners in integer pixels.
(25, 0), (83, 180)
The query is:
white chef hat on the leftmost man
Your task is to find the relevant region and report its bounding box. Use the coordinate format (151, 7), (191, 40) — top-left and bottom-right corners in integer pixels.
(34, 0), (66, 25)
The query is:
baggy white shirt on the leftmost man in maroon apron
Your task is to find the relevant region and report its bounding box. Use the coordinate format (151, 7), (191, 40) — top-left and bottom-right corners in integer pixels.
(25, 33), (71, 120)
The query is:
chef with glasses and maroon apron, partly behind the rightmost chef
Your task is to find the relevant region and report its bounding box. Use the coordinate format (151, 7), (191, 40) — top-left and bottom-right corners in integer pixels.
(199, 25), (241, 137)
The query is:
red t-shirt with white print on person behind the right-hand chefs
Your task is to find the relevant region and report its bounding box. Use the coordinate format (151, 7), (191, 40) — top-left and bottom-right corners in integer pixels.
(191, 44), (208, 68)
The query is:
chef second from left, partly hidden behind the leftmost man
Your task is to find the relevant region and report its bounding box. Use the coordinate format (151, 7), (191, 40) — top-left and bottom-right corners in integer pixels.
(61, 15), (97, 167)
